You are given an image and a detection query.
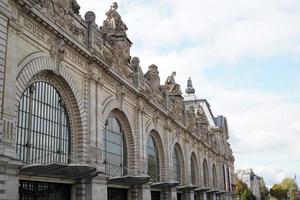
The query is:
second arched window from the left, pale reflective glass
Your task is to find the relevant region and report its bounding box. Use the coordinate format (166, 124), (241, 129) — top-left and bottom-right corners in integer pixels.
(104, 116), (127, 176)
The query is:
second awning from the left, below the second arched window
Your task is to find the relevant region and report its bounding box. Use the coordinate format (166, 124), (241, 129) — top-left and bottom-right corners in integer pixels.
(107, 175), (150, 186)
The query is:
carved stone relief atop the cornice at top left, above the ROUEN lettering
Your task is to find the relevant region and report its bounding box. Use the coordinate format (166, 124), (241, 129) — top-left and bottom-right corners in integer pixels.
(32, 0), (85, 36)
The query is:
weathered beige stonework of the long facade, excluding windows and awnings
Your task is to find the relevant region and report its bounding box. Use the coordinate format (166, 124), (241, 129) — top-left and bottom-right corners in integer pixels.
(0, 0), (234, 200)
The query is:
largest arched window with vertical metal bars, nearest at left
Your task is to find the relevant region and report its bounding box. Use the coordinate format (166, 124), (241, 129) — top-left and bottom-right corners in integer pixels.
(17, 81), (71, 164)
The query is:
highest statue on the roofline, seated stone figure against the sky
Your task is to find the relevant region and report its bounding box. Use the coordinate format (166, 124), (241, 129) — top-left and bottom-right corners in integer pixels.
(100, 2), (127, 36)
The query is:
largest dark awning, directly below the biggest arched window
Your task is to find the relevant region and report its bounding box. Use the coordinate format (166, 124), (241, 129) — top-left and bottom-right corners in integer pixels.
(20, 163), (98, 180)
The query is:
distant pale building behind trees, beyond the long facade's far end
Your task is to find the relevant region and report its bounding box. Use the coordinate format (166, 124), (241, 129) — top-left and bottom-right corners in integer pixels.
(235, 169), (262, 200)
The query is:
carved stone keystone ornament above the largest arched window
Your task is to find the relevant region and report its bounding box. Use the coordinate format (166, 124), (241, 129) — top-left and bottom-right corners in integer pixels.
(48, 38), (66, 73)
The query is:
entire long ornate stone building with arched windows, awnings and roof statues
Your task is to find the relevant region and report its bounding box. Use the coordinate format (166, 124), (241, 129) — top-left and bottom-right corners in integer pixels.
(0, 0), (234, 200)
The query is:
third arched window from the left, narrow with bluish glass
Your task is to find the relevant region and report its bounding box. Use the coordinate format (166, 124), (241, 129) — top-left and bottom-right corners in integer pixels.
(147, 136), (160, 182)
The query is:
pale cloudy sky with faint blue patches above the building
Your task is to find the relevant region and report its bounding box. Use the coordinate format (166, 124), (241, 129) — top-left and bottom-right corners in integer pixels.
(77, 0), (300, 188)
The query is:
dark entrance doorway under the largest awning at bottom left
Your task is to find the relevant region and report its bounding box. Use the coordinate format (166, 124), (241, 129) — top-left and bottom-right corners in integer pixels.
(19, 180), (71, 200)
